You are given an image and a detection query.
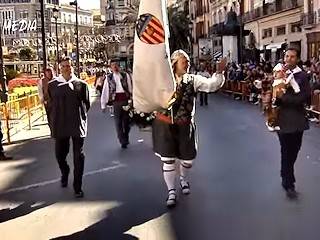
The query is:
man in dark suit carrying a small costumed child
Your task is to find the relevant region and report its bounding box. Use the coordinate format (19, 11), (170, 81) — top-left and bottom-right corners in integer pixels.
(276, 48), (311, 198)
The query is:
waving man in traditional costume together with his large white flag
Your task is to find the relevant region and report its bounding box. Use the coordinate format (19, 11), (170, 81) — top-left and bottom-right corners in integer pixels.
(133, 0), (225, 207)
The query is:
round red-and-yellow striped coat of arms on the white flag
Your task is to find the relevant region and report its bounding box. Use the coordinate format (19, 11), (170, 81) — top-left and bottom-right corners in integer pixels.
(136, 14), (165, 44)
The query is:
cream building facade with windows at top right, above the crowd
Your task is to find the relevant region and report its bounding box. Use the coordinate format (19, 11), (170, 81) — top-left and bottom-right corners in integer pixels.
(243, 0), (307, 63)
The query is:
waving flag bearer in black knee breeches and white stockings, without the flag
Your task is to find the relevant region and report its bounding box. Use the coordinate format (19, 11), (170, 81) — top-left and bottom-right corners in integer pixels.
(153, 50), (225, 207)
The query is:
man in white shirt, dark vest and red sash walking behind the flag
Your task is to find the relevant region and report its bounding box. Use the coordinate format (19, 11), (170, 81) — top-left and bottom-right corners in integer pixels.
(101, 60), (132, 149)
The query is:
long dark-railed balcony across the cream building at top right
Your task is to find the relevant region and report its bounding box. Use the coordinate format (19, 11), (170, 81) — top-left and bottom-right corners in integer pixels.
(243, 0), (303, 23)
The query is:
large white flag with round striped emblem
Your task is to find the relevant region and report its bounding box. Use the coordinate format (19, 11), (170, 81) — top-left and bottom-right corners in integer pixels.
(133, 0), (174, 112)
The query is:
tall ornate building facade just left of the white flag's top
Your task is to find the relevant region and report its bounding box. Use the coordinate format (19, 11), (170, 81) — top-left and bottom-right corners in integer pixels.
(100, 0), (139, 68)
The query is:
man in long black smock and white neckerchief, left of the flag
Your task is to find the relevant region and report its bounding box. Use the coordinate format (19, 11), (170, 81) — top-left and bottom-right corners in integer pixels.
(48, 57), (90, 198)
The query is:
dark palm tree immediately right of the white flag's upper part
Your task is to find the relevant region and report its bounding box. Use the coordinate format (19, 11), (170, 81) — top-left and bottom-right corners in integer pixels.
(168, 6), (191, 52)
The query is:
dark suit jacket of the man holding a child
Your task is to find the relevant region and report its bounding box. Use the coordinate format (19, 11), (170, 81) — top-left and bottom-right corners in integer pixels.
(277, 72), (311, 133)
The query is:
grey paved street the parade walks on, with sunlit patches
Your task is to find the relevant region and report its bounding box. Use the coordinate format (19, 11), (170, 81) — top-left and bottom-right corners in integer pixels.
(0, 94), (320, 240)
